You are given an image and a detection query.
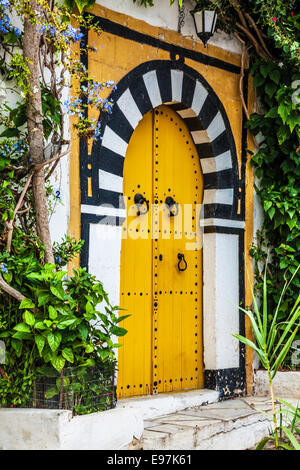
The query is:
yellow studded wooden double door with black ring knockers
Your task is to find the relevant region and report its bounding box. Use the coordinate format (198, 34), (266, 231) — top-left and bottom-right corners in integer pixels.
(117, 105), (203, 398)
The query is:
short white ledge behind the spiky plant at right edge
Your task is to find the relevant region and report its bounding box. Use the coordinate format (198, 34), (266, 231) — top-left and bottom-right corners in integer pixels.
(254, 370), (300, 399)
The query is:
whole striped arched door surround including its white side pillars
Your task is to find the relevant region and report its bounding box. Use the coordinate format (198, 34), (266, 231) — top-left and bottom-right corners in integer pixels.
(80, 60), (245, 396)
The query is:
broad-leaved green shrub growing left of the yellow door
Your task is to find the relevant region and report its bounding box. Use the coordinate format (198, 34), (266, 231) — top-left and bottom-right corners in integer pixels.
(0, 240), (128, 406)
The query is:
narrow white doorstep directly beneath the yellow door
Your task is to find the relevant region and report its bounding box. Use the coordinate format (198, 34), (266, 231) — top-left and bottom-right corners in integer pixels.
(117, 388), (219, 419)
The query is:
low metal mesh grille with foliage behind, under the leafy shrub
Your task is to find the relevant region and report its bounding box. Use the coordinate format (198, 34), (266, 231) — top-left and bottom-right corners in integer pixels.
(28, 363), (116, 415)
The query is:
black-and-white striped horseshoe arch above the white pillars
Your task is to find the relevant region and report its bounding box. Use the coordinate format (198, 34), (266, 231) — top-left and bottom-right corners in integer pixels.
(81, 61), (243, 228)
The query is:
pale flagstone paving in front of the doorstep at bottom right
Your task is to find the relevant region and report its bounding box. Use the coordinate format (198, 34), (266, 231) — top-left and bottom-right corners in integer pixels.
(141, 397), (295, 450)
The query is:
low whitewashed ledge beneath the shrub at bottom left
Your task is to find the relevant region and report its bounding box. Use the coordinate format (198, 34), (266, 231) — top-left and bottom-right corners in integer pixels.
(0, 408), (144, 450)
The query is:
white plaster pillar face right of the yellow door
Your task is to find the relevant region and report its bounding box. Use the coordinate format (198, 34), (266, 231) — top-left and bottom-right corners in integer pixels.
(203, 233), (239, 370)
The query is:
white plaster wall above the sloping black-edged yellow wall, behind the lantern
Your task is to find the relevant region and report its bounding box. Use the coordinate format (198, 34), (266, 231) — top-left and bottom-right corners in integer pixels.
(96, 0), (241, 54)
